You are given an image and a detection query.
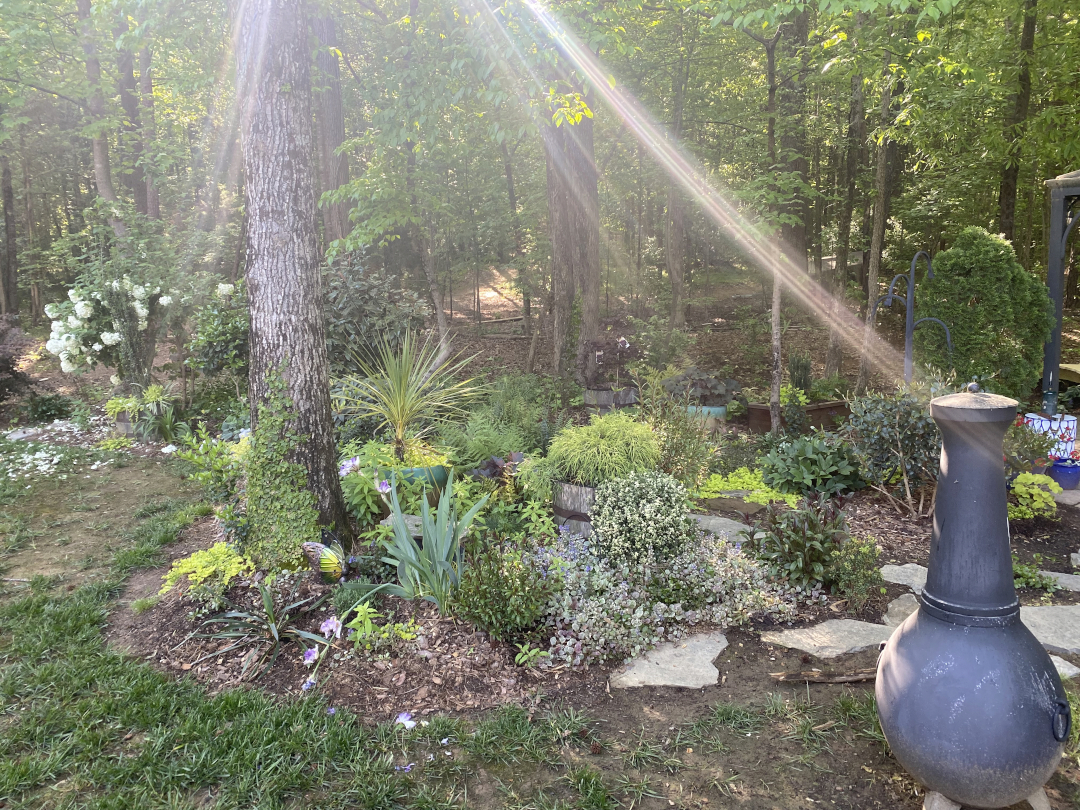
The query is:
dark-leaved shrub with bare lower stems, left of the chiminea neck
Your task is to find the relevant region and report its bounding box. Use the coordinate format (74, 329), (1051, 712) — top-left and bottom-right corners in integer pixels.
(842, 393), (941, 511)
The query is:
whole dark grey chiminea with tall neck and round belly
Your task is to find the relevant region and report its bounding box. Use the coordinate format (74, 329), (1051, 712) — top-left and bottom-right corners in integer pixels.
(876, 393), (1070, 808)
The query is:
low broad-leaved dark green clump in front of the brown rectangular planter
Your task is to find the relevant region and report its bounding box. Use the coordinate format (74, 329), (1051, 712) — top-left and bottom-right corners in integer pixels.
(761, 434), (862, 495)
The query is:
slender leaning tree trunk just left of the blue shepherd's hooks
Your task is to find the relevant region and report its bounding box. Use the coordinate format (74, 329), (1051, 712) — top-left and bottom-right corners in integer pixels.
(825, 64), (866, 377)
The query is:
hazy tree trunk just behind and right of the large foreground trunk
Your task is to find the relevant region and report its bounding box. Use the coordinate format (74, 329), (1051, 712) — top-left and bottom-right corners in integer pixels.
(311, 14), (351, 244)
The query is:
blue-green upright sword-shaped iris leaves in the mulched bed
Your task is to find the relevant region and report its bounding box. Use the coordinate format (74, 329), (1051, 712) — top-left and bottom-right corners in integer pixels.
(382, 473), (488, 616)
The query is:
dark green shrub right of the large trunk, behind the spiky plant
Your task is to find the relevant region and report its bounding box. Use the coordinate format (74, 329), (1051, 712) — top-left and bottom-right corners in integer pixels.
(323, 261), (428, 375)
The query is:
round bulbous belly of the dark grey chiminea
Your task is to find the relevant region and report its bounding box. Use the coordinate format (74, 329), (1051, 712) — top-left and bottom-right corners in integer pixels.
(876, 609), (1068, 808)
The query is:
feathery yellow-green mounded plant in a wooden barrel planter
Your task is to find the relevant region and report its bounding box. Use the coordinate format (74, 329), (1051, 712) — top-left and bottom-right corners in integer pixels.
(545, 413), (661, 537)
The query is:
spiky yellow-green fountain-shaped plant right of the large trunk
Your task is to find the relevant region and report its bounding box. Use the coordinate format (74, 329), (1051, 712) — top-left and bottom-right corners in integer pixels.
(336, 332), (483, 461)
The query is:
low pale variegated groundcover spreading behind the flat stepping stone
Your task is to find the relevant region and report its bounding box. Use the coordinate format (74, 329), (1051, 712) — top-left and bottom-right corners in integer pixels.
(531, 534), (795, 666)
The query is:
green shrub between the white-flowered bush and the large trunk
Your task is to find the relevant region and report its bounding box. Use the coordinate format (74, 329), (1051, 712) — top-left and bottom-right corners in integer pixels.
(186, 282), (251, 380)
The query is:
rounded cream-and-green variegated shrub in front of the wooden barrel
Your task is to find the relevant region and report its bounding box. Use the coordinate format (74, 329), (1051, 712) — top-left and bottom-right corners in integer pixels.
(591, 473), (694, 561)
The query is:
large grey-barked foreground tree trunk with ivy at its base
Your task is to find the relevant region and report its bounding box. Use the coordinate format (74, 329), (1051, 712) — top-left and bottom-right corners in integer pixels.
(235, 0), (351, 546)
